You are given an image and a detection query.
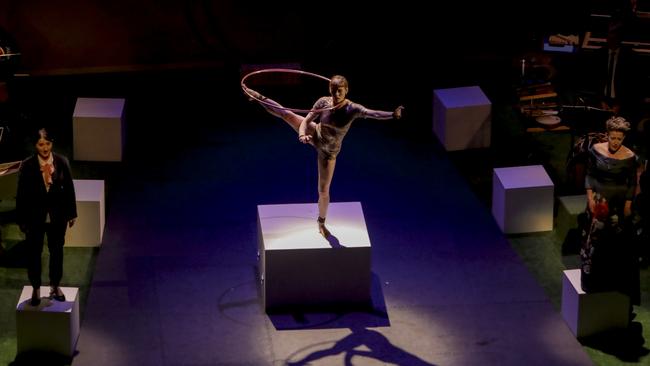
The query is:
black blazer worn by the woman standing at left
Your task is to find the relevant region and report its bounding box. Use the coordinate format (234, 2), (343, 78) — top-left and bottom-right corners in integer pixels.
(16, 152), (77, 227)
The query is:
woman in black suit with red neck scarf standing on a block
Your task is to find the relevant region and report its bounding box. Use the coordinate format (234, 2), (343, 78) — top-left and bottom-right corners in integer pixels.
(16, 128), (77, 306)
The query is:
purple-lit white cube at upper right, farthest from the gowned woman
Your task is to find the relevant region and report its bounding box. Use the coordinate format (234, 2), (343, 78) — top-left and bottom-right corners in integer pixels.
(433, 86), (492, 151)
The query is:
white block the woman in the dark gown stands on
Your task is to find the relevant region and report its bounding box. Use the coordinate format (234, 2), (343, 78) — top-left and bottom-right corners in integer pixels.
(562, 269), (630, 337)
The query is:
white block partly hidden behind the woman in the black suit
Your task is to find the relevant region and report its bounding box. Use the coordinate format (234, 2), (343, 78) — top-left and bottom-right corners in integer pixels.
(65, 179), (106, 247)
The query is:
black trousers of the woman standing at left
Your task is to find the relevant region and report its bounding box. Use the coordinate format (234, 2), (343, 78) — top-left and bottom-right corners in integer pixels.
(25, 222), (67, 288)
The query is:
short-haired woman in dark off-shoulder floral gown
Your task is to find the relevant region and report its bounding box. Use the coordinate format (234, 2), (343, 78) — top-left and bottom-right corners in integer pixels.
(580, 117), (640, 305)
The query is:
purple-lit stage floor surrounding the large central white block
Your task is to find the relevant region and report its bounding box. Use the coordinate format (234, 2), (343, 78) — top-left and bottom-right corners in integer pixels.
(62, 75), (592, 366)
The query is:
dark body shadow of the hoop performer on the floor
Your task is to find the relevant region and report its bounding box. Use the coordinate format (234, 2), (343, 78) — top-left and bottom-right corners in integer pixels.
(286, 325), (435, 366)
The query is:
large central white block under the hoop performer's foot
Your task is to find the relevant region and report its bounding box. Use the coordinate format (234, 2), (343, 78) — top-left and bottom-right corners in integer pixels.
(257, 202), (371, 311)
